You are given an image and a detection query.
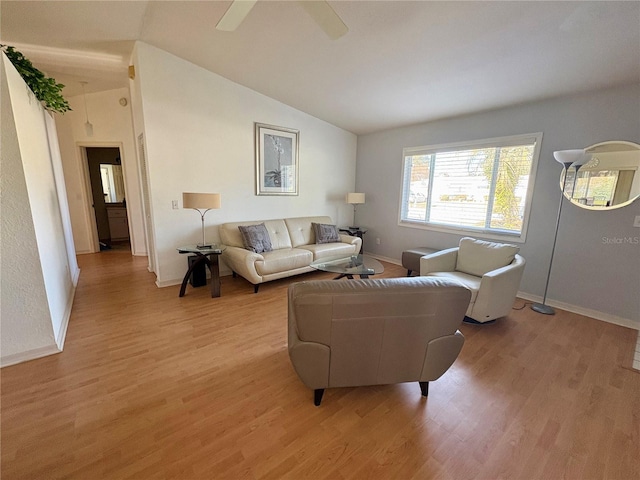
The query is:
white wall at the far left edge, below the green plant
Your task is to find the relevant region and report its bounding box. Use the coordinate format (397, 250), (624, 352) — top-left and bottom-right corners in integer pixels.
(0, 55), (79, 366)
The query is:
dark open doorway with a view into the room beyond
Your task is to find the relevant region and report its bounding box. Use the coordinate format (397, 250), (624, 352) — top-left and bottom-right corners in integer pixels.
(84, 147), (131, 251)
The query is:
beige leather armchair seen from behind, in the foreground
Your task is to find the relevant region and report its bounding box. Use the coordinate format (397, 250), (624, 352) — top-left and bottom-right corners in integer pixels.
(289, 277), (471, 405)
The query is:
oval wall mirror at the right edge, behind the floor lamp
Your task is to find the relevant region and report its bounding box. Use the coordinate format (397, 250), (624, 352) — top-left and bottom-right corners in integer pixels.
(560, 141), (640, 210)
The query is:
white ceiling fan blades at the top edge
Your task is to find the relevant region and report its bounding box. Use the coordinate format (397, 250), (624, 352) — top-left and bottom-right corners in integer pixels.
(216, 0), (349, 40)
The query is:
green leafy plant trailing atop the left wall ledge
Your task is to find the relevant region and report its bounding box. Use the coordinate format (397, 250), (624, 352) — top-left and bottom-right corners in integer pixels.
(0, 45), (71, 113)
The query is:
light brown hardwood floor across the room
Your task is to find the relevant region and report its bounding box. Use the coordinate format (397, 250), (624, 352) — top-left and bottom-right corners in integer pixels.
(0, 251), (640, 480)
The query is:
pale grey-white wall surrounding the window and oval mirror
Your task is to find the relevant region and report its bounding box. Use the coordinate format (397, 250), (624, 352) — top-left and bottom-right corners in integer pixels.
(356, 85), (640, 328)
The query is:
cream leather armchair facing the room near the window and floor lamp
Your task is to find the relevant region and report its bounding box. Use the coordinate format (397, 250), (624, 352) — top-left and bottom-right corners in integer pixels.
(420, 237), (525, 323)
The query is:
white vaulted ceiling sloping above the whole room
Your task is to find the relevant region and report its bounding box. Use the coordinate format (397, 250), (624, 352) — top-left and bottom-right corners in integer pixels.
(0, 0), (640, 134)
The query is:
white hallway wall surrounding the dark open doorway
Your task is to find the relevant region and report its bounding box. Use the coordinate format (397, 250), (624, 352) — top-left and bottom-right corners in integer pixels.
(56, 88), (147, 255)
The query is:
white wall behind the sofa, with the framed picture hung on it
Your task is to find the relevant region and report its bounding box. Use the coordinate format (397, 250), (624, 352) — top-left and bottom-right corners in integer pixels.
(131, 43), (356, 286)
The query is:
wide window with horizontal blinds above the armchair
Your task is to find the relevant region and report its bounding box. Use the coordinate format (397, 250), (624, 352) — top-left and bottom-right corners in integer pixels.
(400, 133), (542, 240)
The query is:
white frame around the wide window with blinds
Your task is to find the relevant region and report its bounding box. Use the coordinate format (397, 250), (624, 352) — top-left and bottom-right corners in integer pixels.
(398, 132), (542, 243)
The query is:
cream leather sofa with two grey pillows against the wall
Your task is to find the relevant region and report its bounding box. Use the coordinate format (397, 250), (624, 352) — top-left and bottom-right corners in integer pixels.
(219, 216), (362, 293)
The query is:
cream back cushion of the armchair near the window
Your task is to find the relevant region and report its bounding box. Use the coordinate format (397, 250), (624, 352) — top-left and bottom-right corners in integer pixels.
(456, 237), (520, 277)
